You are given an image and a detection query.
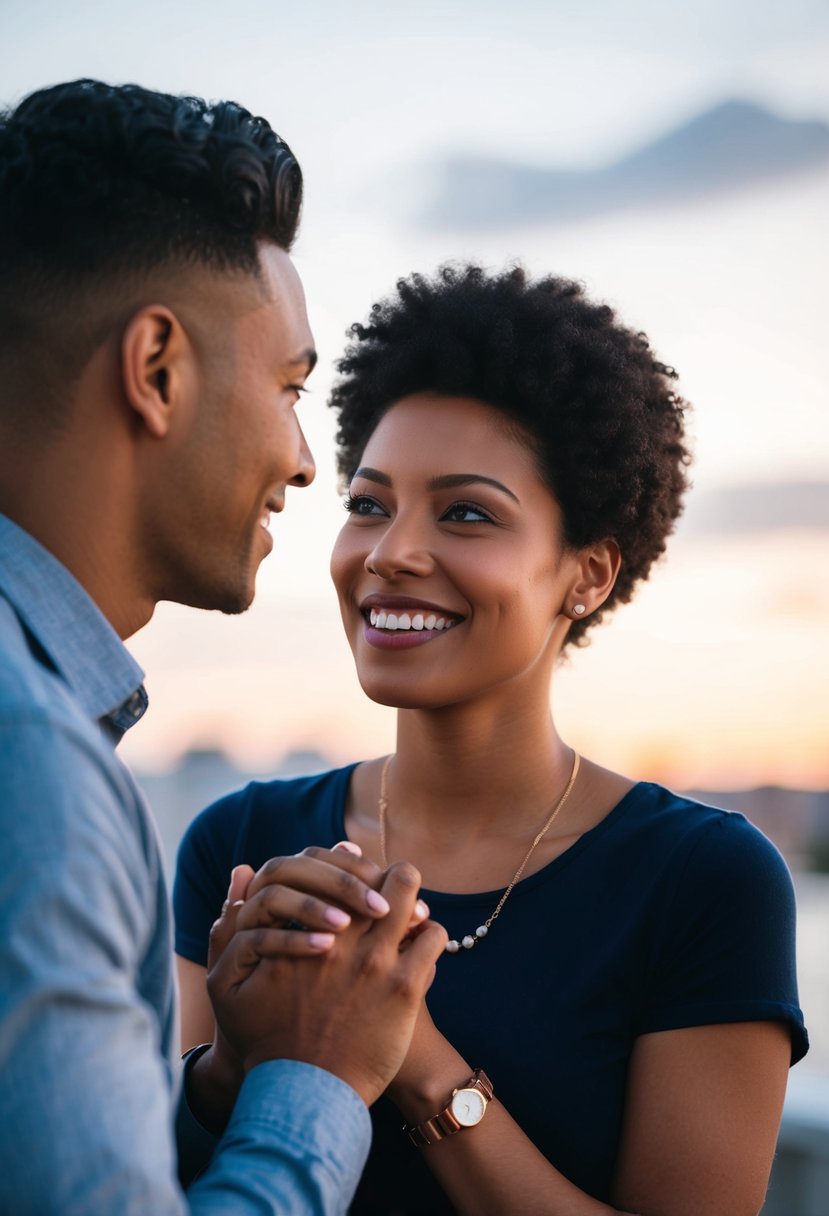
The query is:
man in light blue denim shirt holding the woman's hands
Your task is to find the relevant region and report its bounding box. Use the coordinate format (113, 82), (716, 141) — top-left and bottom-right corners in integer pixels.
(0, 81), (445, 1216)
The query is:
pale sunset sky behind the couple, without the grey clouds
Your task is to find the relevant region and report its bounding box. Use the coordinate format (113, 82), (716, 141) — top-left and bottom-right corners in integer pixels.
(0, 0), (829, 788)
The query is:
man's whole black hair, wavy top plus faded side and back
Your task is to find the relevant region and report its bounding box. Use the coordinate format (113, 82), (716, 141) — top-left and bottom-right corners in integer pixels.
(0, 80), (303, 422)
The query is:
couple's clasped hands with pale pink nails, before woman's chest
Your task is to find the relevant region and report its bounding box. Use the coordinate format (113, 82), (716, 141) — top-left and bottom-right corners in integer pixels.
(188, 845), (446, 1128)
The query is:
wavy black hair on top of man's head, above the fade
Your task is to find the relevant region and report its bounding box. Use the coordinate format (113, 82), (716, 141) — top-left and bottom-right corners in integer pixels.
(0, 80), (303, 275)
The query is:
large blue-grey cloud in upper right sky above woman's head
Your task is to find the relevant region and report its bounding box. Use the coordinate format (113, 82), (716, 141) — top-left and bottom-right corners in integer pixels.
(423, 101), (829, 227)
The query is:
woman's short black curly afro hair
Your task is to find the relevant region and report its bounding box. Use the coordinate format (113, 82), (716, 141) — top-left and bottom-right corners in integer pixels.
(331, 265), (690, 641)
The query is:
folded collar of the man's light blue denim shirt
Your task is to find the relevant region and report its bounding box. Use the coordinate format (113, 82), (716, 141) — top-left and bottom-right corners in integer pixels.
(0, 514), (147, 742)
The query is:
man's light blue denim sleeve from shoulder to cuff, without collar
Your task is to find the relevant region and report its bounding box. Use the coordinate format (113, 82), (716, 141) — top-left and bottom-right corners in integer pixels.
(0, 720), (370, 1216)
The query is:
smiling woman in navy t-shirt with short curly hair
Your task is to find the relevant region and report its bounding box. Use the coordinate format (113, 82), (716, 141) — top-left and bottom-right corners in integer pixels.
(176, 268), (806, 1216)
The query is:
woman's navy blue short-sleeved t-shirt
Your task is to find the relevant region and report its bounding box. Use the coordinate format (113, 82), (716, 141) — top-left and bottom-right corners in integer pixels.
(174, 765), (808, 1216)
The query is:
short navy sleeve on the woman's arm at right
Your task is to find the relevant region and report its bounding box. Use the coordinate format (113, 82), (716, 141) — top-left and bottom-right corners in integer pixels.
(637, 811), (808, 1063)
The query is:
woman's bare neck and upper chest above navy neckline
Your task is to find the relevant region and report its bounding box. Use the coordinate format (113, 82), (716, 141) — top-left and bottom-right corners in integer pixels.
(345, 689), (632, 893)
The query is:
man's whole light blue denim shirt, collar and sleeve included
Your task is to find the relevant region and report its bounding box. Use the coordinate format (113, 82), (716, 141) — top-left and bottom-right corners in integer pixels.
(0, 516), (371, 1216)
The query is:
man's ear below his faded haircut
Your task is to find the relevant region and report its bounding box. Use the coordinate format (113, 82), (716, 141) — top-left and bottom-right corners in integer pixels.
(120, 304), (192, 439)
